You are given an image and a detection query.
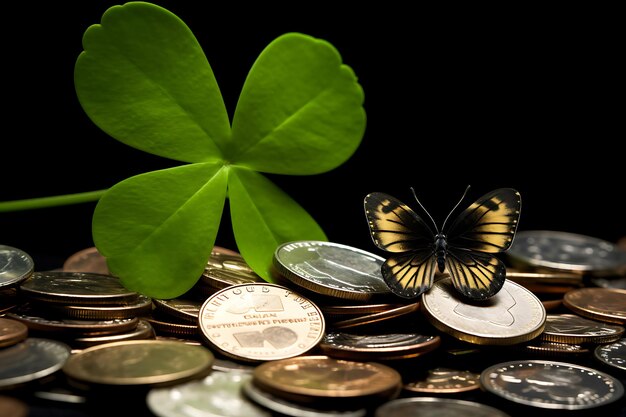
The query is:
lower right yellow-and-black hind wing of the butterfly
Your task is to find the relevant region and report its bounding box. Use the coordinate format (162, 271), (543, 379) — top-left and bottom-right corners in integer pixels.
(446, 247), (506, 300)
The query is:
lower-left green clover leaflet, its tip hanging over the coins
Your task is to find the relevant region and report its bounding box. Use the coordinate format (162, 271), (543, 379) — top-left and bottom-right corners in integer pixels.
(93, 163), (228, 298)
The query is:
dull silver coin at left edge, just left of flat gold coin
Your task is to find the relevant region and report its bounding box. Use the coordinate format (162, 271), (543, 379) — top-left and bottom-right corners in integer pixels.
(0, 337), (71, 388)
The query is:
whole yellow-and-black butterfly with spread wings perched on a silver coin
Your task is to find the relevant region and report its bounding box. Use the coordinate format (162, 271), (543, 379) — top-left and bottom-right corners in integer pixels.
(364, 186), (522, 300)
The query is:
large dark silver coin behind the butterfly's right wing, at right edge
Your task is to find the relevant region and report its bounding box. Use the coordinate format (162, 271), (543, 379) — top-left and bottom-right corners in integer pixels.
(507, 230), (626, 273)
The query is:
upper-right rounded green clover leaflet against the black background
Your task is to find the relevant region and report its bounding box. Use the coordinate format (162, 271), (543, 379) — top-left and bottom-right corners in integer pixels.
(228, 33), (365, 175)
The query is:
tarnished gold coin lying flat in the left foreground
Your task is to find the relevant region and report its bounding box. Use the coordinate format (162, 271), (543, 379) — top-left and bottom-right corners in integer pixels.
(62, 340), (214, 386)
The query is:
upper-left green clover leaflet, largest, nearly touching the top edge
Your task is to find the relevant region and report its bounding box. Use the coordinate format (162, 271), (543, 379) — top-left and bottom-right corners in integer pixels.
(74, 2), (230, 162)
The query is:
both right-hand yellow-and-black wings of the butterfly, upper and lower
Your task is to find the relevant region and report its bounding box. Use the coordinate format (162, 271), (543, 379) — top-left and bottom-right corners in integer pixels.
(443, 188), (522, 300)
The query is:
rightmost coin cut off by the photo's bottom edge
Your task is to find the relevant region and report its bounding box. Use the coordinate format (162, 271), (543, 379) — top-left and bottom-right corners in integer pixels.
(374, 397), (508, 417)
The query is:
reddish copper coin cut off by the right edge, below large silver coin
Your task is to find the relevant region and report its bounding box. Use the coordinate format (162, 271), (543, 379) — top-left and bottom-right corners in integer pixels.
(563, 288), (626, 324)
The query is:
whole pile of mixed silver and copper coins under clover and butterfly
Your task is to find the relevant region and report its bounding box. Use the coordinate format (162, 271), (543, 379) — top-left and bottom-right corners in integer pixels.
(0, 231), (626, 417)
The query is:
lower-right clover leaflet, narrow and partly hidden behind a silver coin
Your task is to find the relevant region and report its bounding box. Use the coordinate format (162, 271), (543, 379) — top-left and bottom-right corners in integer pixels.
(228, 168), (327, 282)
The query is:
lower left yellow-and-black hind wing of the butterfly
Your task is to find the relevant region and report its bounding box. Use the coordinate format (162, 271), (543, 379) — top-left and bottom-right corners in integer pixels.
(381, 249), (436, 298)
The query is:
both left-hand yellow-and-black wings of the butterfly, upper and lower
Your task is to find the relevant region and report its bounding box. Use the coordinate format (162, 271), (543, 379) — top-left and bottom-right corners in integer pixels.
(364, 192), (436, 298)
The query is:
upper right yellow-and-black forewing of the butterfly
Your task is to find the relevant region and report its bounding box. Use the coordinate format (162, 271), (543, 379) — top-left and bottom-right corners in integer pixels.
(443, 188), (522, 253)
